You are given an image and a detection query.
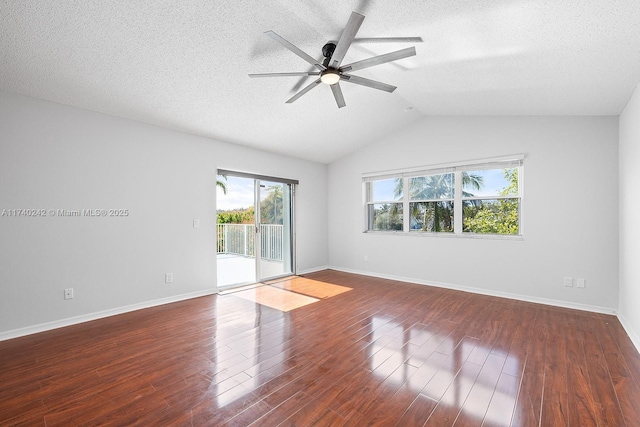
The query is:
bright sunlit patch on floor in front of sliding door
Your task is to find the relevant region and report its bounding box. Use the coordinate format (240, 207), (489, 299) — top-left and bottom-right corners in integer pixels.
(229, 276), (351, 311)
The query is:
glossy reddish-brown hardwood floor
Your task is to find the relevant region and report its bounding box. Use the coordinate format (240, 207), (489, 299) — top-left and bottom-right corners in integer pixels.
(0, 271), (640, 426)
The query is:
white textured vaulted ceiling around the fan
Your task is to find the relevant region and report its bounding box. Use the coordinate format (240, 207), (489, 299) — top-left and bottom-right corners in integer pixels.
(0, 0), (640, 163)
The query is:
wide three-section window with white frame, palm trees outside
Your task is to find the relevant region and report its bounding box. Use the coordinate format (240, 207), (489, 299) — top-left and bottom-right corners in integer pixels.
(363, 156), (524, 236)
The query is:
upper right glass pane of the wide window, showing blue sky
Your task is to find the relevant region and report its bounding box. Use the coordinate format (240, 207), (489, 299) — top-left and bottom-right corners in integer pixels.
(462, 168), (518, 197)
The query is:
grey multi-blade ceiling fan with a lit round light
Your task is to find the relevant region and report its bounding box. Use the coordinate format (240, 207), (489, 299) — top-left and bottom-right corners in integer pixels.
(249, 12), (422, 108)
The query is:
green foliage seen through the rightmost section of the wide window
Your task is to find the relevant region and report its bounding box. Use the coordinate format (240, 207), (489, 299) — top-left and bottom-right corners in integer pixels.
(462, 169), (520, 234)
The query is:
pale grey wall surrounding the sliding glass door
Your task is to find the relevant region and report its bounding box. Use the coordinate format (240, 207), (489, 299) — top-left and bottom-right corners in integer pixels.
(0, 92), (327, 339)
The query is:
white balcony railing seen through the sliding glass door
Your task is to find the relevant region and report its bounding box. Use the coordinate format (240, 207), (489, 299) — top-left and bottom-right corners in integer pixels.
(217, 224), (283, 261)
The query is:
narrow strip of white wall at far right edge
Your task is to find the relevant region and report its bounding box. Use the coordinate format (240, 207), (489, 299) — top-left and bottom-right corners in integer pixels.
(619, 86), (640, 351)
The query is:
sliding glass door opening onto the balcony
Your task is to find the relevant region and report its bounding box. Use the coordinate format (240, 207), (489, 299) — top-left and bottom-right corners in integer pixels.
(216, 170), (297, 289)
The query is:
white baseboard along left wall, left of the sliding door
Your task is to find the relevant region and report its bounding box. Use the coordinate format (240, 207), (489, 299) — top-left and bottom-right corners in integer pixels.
(0, 289), (218, 341)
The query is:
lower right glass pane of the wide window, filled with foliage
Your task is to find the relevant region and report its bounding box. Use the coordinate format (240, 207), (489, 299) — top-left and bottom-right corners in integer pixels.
(462, 199), (520, 234)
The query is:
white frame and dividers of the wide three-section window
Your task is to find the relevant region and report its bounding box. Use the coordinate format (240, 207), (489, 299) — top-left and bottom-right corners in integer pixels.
(362, 154), (525, 240)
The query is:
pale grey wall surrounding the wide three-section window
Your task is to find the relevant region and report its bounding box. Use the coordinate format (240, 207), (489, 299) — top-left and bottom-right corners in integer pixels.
(328, 117), (618, 312)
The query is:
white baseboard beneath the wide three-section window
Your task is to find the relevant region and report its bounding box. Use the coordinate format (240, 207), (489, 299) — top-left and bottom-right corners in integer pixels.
(329, 267), (617, 315)
